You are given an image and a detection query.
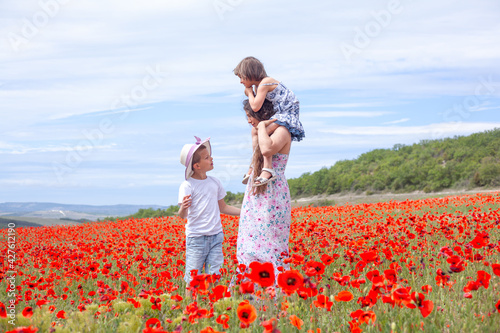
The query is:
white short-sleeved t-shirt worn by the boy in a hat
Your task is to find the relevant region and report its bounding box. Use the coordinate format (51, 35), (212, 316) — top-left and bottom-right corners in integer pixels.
(179, 176), (226, 237)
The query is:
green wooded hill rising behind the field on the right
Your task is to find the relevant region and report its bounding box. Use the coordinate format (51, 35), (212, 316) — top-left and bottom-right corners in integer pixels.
(288, 129), (500, 198)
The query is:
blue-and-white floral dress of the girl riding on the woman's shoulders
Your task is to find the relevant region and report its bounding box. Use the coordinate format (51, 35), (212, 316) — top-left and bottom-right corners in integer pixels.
(263, 82), (305, 141)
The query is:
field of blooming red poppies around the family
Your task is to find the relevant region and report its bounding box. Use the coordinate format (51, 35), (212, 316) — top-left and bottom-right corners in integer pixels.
(0, 192), (500, 333)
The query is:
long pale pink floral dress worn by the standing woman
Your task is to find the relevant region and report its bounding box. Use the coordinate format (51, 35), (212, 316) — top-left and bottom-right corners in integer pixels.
(237, 153), (291, 276)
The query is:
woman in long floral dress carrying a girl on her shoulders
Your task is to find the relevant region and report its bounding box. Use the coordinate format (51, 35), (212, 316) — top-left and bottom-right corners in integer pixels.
(237, 100), (292, 276)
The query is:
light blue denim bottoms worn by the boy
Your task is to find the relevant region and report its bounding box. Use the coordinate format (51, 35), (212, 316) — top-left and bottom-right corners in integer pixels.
(184, 232), (224, 283)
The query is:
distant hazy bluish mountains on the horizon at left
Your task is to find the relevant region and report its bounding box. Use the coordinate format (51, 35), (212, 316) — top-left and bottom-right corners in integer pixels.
(0, 202), (167, 219)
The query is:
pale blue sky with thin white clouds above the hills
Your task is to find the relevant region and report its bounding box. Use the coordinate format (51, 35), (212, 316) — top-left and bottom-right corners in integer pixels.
(0, 0), (500, 206)
